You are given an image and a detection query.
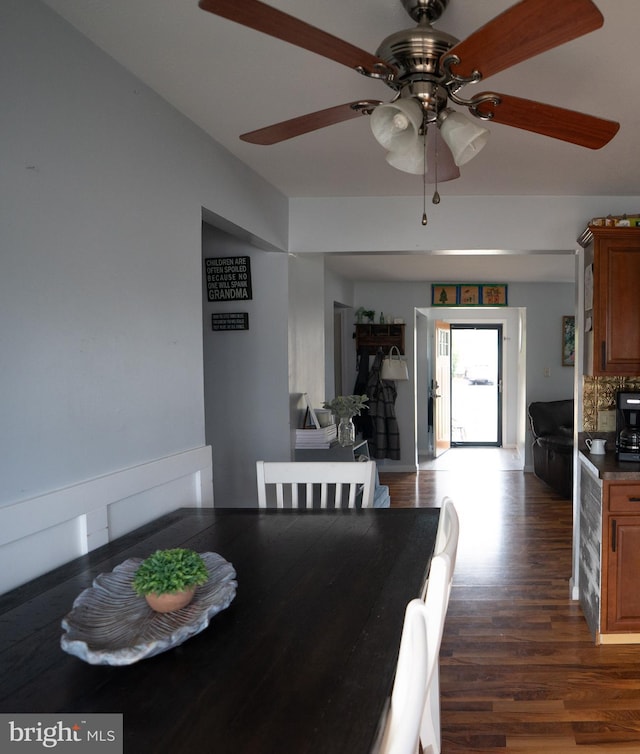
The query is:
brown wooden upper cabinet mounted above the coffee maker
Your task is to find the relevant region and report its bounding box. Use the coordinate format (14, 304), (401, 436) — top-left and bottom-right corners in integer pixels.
(580, 226), (640, 376)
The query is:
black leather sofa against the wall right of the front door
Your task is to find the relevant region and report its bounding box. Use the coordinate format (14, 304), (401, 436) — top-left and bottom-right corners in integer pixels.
(528, 398), (573, 498)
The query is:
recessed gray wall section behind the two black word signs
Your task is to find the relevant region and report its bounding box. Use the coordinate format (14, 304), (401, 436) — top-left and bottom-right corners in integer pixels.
(202, 224), (290, 507)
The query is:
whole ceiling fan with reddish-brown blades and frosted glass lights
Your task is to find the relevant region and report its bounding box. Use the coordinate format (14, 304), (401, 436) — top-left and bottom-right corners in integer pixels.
(199, 0), (620, 184)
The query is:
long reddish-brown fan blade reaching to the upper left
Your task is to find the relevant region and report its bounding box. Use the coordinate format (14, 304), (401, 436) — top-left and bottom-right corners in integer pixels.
(198, 0), (395, 78)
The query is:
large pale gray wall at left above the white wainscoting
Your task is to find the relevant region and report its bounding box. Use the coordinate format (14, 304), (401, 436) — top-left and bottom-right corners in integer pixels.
(0, 0), (288, 505)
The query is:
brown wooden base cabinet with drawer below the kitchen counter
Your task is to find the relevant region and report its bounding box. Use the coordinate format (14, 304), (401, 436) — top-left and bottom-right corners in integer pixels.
(601, 482), (640, 634)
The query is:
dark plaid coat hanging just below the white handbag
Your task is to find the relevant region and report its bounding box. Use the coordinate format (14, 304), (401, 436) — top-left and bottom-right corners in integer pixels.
(367, 350), (400, 461)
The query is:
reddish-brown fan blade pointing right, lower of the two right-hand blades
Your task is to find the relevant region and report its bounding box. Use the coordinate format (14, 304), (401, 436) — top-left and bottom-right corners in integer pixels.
(477, 94), (620, 149)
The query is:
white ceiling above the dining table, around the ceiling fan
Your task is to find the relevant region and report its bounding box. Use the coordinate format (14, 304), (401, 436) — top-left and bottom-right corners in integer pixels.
(44, 0), (640, 282)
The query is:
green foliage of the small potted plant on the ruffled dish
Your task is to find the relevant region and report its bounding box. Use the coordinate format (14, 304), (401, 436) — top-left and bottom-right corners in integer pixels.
(132, 548), (209, 596)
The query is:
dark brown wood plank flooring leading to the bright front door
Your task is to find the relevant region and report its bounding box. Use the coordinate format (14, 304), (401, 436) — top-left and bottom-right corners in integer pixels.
(380, 468), (640, 754)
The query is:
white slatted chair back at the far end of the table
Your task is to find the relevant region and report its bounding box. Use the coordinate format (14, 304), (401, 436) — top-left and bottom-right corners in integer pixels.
(256, 461), (376, 508)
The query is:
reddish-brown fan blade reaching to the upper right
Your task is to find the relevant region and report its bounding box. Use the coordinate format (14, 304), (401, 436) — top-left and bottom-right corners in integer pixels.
(443, 0), (604, 78)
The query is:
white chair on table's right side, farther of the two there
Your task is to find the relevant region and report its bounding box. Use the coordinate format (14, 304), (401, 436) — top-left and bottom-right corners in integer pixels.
(420, 497), (460, 754)
